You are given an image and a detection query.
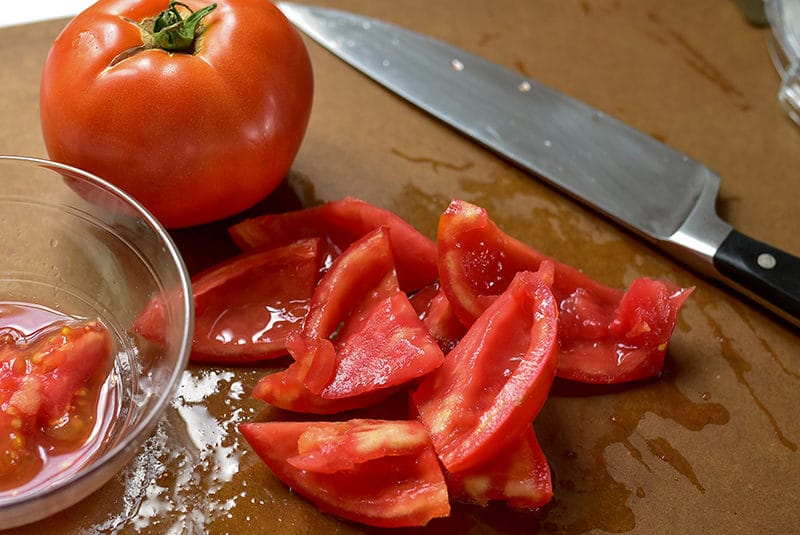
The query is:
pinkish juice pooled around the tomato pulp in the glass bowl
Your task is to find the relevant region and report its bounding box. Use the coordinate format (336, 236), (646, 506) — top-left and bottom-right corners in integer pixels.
(0, 302), (120, 498)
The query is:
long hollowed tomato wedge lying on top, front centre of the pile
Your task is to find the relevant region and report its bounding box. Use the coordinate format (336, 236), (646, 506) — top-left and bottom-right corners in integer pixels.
(412, 266), (558, 472)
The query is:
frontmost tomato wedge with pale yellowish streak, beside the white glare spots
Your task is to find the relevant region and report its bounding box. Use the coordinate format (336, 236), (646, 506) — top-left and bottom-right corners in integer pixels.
(239, 420), (450, 527)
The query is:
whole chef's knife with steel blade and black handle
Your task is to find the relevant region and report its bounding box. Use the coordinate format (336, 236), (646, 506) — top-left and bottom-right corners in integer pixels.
(277, 2), (800, 325)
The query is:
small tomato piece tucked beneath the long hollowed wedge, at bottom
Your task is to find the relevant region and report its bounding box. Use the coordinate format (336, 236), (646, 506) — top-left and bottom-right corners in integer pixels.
(445, 427), (553, 509)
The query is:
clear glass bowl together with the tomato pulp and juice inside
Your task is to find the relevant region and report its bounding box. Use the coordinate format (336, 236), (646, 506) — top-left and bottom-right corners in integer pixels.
(0, 156), (194, 528)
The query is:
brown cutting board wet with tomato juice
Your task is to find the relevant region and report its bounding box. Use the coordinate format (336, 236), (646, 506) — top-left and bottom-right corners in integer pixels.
(0, 0), (800, 533)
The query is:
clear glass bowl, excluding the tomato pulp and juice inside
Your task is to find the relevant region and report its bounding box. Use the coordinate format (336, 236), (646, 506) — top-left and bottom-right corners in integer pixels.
(0, 156), (194, 528)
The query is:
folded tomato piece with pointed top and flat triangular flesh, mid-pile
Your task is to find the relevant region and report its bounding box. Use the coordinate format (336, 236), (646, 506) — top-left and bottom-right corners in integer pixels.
(254, 228), (444, 410)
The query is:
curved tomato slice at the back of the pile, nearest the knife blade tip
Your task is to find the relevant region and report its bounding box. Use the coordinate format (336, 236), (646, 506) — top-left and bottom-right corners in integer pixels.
(229, 197), (438, 292)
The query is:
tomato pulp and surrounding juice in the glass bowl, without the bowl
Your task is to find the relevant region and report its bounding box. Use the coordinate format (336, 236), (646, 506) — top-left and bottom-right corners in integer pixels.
(0, 302), (121, 496)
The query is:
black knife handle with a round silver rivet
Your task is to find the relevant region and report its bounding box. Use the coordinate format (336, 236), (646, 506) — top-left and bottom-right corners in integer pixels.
(714, 230), (800, 326)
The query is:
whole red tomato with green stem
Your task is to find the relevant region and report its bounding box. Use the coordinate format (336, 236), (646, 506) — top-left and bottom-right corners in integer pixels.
(40, 0), (313, 227)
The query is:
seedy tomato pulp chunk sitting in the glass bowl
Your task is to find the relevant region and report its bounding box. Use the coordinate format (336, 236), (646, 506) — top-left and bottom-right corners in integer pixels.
(0, 321), (113, 489)
